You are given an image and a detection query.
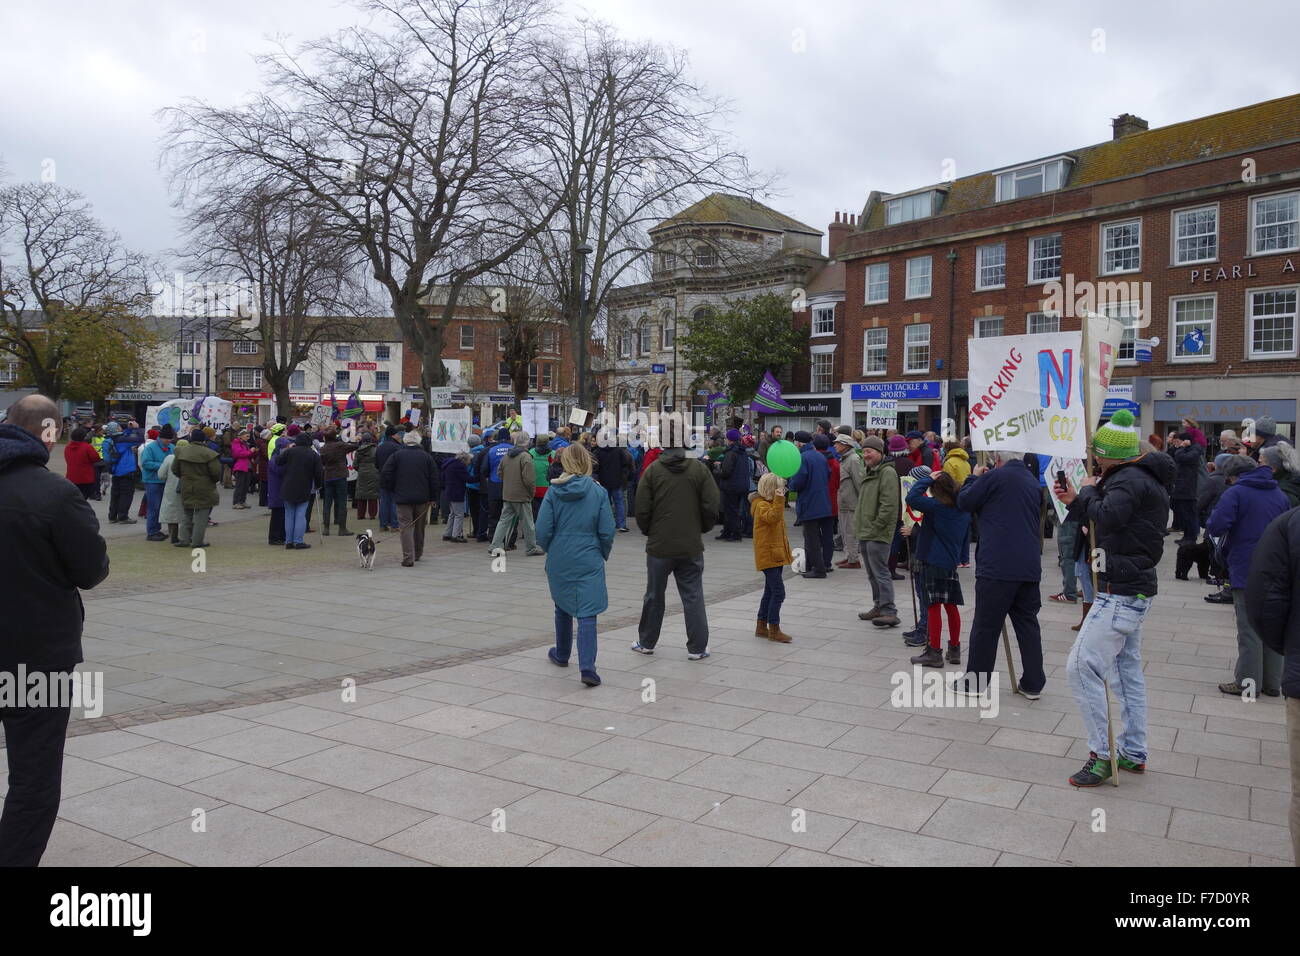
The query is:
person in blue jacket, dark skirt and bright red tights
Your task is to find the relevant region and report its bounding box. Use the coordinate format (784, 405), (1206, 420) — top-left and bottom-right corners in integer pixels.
(904, 467), (971, 667)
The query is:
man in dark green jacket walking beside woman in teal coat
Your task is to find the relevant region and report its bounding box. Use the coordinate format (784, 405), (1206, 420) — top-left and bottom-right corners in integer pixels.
(632, 447), (720, 661)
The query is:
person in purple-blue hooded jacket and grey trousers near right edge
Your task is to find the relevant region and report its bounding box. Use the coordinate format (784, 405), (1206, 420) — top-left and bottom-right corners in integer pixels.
(1205, 455), (1291, 697)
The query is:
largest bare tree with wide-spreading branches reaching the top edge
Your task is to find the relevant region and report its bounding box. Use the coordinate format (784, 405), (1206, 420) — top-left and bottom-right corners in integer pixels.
(164, 0), (567, 402)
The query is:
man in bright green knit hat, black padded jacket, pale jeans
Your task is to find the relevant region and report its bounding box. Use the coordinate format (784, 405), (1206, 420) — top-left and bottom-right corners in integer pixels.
(1054, 408), (1175, 787)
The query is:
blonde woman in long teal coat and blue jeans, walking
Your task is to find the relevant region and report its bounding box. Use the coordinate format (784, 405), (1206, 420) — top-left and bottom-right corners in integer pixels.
(537, 445), (614, 687)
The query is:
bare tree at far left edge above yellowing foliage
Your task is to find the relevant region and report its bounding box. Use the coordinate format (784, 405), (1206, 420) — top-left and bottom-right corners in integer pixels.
(0, 183), (156, 401)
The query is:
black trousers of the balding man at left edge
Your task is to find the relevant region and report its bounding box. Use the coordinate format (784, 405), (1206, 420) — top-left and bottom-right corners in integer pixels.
(0, 674), (70, 866)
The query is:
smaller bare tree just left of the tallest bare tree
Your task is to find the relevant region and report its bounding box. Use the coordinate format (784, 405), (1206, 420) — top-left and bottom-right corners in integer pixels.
(175, 182), (368, 415)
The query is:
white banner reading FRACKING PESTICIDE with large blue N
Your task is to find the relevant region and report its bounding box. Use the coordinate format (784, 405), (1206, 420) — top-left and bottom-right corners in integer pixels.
(966, 332), (1087, 458)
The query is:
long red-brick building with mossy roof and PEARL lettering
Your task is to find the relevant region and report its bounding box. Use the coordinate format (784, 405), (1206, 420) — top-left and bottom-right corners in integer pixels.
(832, 96), (1300, 444)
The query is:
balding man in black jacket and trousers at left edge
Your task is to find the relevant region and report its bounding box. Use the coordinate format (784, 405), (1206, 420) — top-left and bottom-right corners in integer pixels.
(0, 394), (108, 866)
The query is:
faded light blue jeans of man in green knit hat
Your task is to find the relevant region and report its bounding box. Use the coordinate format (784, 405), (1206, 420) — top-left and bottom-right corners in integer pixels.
(1066, 594), (1152, 763)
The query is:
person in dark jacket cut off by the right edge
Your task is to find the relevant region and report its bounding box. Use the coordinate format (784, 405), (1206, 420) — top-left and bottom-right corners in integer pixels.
(1245, 509), (1300, 862)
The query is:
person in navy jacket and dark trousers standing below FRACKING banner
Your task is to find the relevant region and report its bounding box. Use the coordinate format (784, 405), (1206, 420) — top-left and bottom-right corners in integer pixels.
(956, 451), (1048, 700)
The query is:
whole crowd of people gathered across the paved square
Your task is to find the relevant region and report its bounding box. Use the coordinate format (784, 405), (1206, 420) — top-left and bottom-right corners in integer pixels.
(0, 395), (1300, 858)
